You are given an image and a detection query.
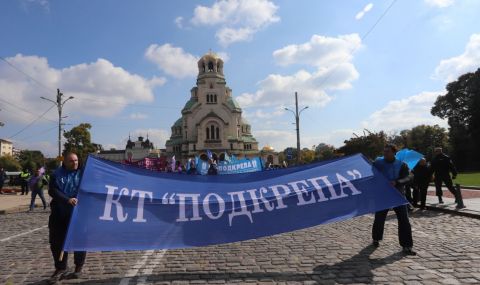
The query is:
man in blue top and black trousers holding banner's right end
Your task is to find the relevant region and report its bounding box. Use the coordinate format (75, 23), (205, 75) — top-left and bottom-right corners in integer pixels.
(372, 144), (416, 255)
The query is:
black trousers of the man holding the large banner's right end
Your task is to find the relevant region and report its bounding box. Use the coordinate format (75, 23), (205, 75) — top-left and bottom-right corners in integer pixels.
(372, 205), (413, 247)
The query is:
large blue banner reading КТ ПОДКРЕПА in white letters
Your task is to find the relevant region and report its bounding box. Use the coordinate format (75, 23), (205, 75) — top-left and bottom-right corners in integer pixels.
(64, 155), (407, 251)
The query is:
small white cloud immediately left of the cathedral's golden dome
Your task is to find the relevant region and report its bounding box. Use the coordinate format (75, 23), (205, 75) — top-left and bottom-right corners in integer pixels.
(145, 43), (198, 79)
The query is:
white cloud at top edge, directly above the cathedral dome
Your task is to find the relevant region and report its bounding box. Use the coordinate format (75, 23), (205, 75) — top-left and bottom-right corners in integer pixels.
(190, 0), (280, 46)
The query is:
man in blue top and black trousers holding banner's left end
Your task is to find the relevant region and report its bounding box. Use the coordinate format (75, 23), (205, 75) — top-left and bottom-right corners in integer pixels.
(48, 153), (87, 284)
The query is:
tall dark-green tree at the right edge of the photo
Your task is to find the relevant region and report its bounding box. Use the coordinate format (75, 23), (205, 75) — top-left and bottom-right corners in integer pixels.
(431, 68), (480, 170)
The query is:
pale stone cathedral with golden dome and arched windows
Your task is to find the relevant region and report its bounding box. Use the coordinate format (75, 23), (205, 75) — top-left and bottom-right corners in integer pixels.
(166, 52), (260, 161)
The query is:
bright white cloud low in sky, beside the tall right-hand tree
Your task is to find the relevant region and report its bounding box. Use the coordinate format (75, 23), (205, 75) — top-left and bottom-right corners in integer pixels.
(362, 91), (447, 131)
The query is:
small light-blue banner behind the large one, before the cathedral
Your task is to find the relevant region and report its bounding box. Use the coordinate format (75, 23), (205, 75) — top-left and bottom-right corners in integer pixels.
(196, 157), (262, 175)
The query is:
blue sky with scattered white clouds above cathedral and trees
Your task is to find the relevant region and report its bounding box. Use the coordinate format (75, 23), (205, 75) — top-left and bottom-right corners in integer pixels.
(0, 0), (480, 156)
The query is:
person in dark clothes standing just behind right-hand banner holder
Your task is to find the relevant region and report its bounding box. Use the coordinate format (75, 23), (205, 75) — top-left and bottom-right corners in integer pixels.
(412, 158), (432, 210)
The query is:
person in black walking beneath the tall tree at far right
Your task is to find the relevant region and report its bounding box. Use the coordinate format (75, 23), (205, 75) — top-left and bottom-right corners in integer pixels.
(432, 147), (465, 206)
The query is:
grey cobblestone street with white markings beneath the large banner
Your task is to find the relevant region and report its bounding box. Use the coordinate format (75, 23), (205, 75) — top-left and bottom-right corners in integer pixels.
(0, 210), (480, 284)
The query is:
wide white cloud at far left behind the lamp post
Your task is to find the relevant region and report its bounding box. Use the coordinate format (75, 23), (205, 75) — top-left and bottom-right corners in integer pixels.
(0, 54), (165, 122)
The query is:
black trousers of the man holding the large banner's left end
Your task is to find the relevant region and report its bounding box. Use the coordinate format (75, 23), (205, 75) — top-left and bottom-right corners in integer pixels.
(48, 203), (87, 269)
